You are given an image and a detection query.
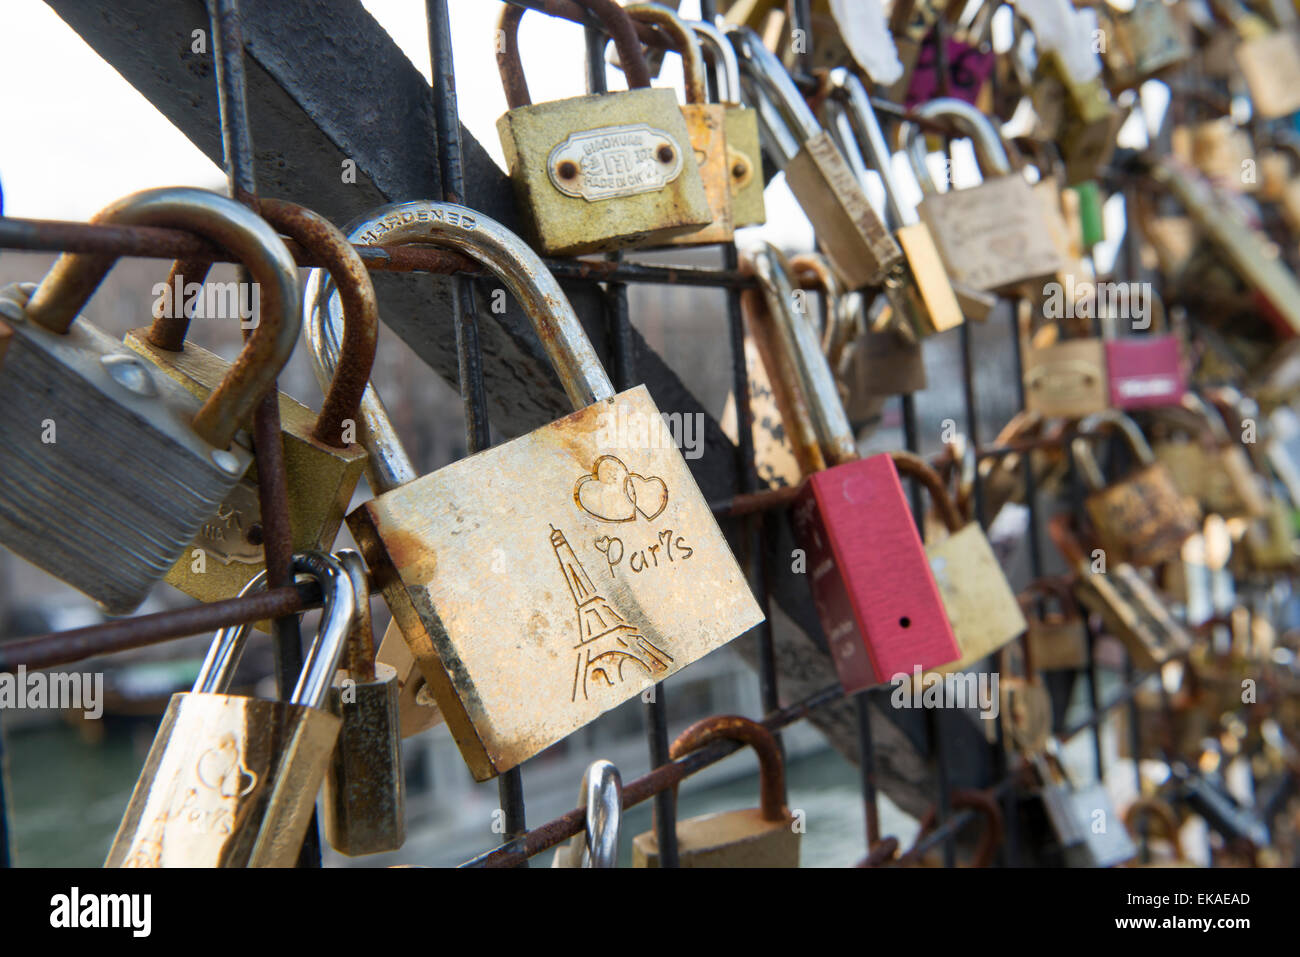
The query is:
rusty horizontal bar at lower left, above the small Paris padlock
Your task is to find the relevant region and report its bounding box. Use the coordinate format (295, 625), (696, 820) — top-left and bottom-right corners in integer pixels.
(0, 583), (321, 672)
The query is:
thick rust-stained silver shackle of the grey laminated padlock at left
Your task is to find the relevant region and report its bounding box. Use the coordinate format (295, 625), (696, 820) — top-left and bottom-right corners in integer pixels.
(25, 186), (302, 449)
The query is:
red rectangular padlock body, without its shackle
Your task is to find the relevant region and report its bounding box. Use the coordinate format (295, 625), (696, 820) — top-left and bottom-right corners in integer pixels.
(792, 455), (961, 693)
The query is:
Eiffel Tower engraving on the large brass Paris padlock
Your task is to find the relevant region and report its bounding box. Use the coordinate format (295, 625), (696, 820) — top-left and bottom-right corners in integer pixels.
(551, 525), (672, 701)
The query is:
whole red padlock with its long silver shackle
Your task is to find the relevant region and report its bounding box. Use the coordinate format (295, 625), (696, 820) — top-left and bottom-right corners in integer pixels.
(753, 247), (961, 693)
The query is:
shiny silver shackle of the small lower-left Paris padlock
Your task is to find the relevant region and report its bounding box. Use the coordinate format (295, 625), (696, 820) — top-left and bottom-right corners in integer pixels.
(191, 551), (360, 709)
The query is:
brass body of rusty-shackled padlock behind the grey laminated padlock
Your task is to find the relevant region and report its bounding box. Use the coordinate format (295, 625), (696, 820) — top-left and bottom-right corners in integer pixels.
(125, 329), (367, 608)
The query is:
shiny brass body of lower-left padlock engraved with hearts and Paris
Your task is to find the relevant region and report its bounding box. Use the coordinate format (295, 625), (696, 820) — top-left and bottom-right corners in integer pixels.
(104, 693), (339, 867)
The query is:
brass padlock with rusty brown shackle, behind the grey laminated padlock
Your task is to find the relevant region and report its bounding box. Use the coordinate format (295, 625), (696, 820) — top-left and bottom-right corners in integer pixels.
(125, 199), (380, 608)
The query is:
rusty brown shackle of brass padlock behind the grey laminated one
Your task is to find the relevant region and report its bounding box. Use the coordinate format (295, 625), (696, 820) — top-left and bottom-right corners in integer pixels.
(253, 199), (380, 449)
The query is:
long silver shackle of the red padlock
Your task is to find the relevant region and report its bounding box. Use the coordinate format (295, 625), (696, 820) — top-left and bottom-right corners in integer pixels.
(750, 243), (858, 465)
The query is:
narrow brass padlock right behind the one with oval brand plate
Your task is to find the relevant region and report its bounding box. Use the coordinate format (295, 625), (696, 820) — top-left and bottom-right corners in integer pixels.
(624, 3), (736, 246)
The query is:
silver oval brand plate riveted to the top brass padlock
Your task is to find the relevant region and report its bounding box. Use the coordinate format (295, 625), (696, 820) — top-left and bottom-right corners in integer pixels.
(546, 124), (683, 203)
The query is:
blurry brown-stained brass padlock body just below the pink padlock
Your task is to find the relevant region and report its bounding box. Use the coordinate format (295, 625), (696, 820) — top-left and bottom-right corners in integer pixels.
(1084, 462), (1200, 566)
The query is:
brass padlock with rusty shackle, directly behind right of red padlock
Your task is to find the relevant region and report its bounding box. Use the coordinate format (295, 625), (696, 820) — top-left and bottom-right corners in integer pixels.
(891, 451), (1026, 674)
